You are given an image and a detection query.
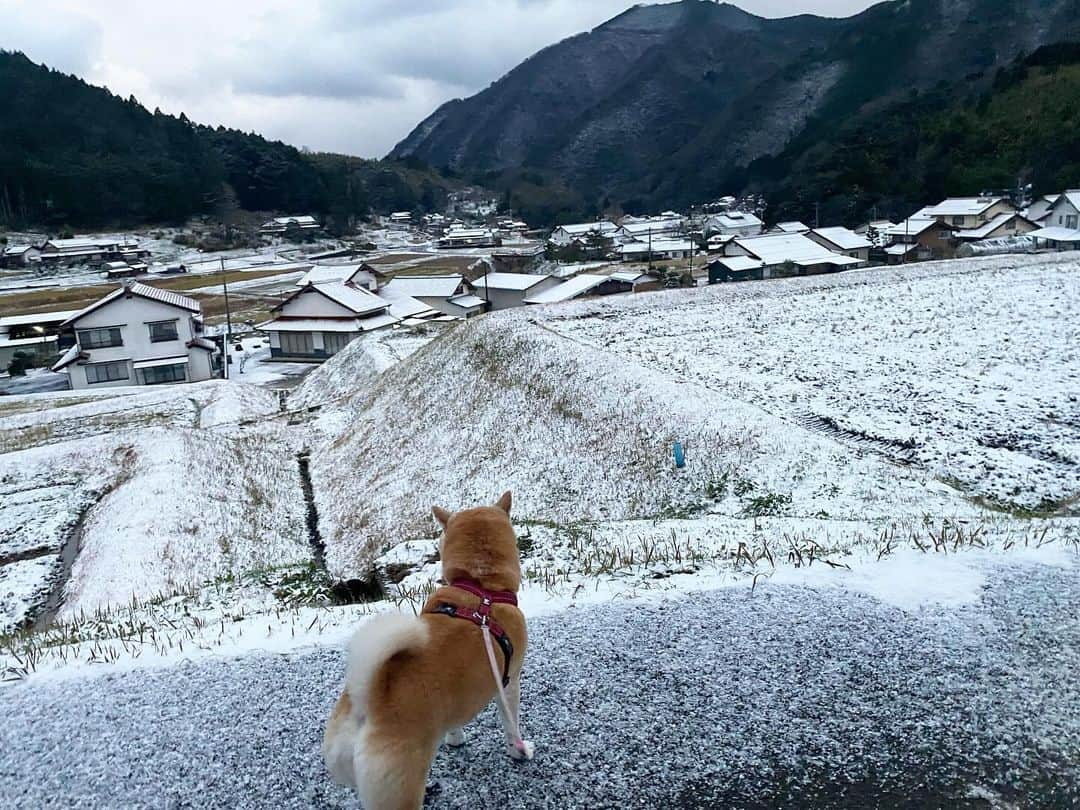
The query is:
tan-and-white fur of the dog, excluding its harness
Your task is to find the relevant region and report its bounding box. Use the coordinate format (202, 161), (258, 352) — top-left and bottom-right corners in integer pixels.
(323, 492), (527, 810)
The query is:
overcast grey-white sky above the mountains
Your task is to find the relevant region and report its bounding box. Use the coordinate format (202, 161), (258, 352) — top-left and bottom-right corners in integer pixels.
(0, 0), (872, 157)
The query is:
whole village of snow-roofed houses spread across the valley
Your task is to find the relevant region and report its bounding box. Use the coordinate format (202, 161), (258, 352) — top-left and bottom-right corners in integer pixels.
(0, 190), (1080, 390)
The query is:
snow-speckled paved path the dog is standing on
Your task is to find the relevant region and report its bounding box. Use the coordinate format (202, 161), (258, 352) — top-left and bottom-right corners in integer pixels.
(0, 567), (1080, 810)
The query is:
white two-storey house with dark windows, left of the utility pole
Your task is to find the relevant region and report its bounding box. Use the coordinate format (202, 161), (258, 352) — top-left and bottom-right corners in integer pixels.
(53, 281), (217, 390)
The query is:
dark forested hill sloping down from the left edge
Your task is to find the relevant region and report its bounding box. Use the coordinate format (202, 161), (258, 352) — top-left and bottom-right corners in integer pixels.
(0, 51), (460, 230)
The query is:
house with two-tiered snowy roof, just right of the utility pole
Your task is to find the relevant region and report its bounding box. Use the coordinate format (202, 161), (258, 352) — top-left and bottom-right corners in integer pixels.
(255, 283), (399, 362)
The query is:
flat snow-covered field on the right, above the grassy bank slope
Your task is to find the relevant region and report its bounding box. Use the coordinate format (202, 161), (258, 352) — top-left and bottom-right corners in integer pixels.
(543, 254), (1080, 514)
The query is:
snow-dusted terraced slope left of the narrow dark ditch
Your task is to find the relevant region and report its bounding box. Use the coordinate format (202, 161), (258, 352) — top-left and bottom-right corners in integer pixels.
(0, 382), (311, 630)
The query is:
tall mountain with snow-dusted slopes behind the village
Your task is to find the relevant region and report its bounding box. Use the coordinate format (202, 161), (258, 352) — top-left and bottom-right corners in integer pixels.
(391, 0), (1080, 220)
